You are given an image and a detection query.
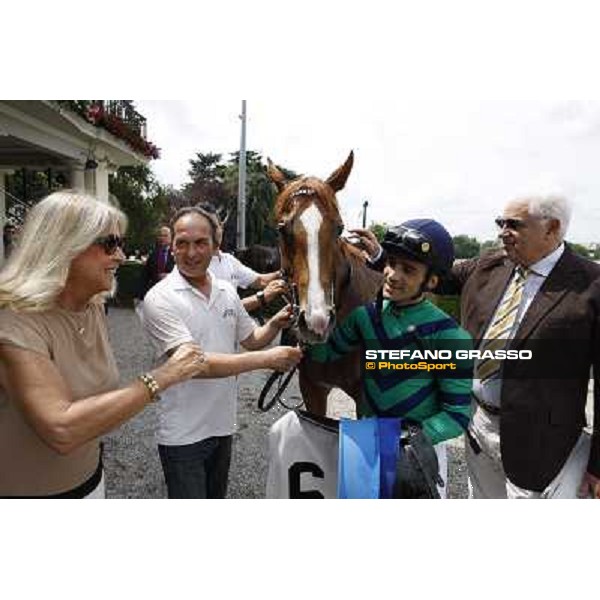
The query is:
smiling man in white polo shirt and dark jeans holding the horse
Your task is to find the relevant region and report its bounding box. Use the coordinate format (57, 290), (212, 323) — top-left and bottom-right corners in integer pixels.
(142, 207), (301, 498)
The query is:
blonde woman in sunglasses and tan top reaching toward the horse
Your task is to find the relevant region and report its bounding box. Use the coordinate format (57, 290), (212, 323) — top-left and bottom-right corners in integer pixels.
(0, 191), (297, 498)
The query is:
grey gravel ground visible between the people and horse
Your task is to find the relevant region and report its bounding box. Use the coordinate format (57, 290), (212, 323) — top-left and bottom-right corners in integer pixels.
(105, 308), (466, 498)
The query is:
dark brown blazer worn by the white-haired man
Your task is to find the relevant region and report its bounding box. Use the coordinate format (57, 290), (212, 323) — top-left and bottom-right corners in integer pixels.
(450, 247), (600, 491)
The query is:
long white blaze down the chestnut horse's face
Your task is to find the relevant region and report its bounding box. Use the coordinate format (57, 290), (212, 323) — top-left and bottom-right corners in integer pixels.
(300, 204), (329, 335)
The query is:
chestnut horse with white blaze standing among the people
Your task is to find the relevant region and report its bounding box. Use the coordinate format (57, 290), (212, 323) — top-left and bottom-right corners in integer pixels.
(268, 152), (381, 415)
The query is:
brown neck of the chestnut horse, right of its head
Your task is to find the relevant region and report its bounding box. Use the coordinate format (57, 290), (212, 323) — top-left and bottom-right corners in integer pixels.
(336, 242), (382, 322)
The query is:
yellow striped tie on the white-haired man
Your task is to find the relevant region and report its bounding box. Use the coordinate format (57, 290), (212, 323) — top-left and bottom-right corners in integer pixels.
(475, 267), (527, 382)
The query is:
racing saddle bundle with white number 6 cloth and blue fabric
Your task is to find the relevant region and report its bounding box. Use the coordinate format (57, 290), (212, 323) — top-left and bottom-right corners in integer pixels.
(266, 411), (443, 499)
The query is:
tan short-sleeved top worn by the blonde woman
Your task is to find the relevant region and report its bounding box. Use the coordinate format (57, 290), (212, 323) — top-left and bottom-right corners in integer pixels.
(0, 304), (119, 496)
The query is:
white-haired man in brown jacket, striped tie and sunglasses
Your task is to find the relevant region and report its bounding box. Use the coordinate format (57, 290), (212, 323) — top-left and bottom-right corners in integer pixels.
(449, 196), (600, 498)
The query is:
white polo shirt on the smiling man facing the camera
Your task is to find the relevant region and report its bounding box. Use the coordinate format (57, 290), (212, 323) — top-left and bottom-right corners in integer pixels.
(142, 267), (256, 446)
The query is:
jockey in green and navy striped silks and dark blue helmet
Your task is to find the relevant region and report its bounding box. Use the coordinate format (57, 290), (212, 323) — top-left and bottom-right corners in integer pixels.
(309, 219), (473, 496)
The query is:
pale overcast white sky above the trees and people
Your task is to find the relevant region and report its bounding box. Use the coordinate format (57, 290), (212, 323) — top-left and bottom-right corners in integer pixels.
(135, 99), (600, 243)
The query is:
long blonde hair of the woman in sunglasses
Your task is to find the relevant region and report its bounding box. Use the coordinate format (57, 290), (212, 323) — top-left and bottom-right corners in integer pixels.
(0, 190), (127, 312)
